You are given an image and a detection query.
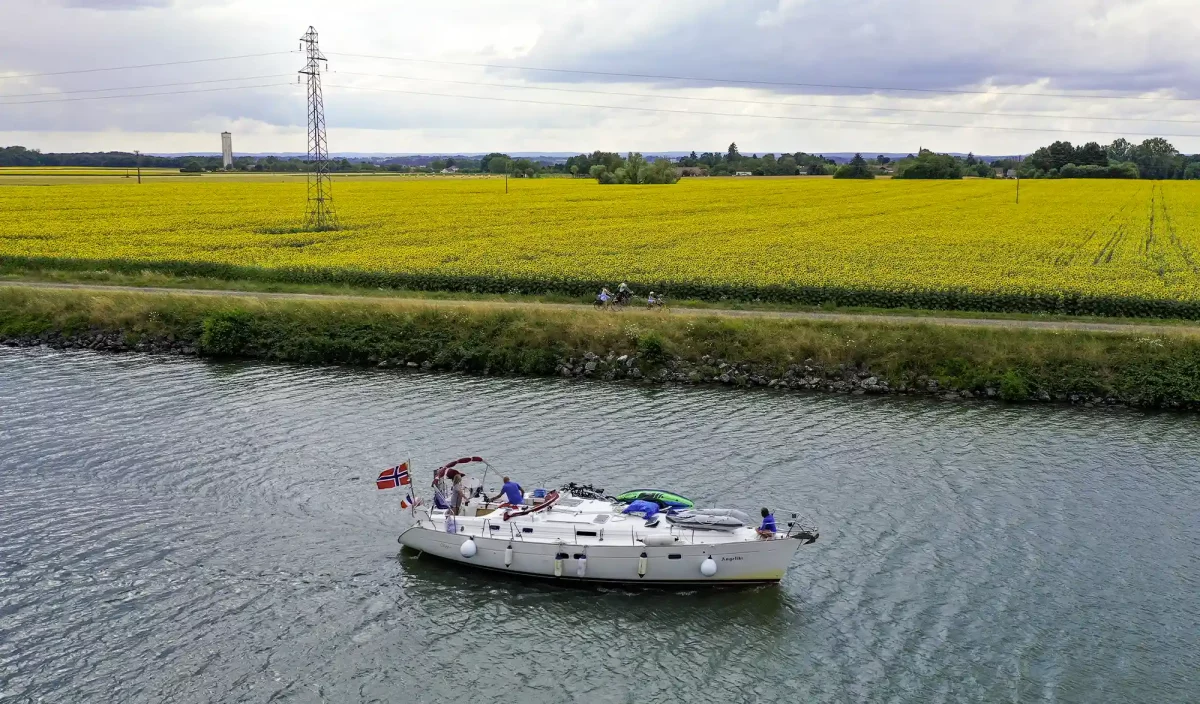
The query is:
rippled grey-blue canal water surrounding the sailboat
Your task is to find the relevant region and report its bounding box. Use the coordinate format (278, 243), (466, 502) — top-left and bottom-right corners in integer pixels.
(0, 349), (1200, 703)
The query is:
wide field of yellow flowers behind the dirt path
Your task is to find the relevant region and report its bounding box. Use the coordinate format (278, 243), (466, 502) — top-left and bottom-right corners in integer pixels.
(0, 179), (1200, 318)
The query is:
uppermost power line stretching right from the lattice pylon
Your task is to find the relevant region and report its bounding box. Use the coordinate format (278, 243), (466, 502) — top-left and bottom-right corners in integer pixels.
(329, 52), (1200, 102)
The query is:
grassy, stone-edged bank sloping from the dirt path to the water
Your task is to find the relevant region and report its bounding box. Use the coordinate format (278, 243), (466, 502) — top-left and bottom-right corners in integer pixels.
(7, 288), (1200, 410)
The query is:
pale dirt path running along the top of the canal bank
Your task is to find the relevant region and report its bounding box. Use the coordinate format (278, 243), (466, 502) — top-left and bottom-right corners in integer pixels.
(0, 281), (1200, 335)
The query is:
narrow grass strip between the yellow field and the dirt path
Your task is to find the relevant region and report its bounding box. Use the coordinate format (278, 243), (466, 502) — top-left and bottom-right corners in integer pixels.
(9, 263), (1195, 326)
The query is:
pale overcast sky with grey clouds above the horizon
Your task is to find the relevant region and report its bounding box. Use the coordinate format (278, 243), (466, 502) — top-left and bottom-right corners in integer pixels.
(0, 0), (1200, 154)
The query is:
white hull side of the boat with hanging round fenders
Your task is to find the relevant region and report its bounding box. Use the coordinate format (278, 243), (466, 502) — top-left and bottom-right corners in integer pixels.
(400, 519), (802, 584)
